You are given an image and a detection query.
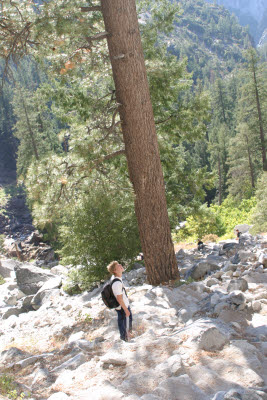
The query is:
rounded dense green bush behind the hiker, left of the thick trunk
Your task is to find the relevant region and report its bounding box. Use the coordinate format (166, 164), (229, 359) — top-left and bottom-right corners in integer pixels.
(59, 188), (140, 289)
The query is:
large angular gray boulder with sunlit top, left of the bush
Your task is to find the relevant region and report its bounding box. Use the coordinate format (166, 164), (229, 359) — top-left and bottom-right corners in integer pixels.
(15, 263), (55, 295)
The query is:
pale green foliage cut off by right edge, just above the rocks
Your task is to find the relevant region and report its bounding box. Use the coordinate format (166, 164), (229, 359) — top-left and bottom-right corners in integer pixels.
(252, 172), (267, 232)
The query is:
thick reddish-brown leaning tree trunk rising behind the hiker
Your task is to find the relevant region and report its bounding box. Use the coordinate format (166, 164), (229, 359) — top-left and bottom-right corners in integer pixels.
(101, 0), (179, 285)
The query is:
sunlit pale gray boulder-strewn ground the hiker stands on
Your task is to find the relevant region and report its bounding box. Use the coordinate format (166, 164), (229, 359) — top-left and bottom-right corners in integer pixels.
(0, 234), (267, 400)
